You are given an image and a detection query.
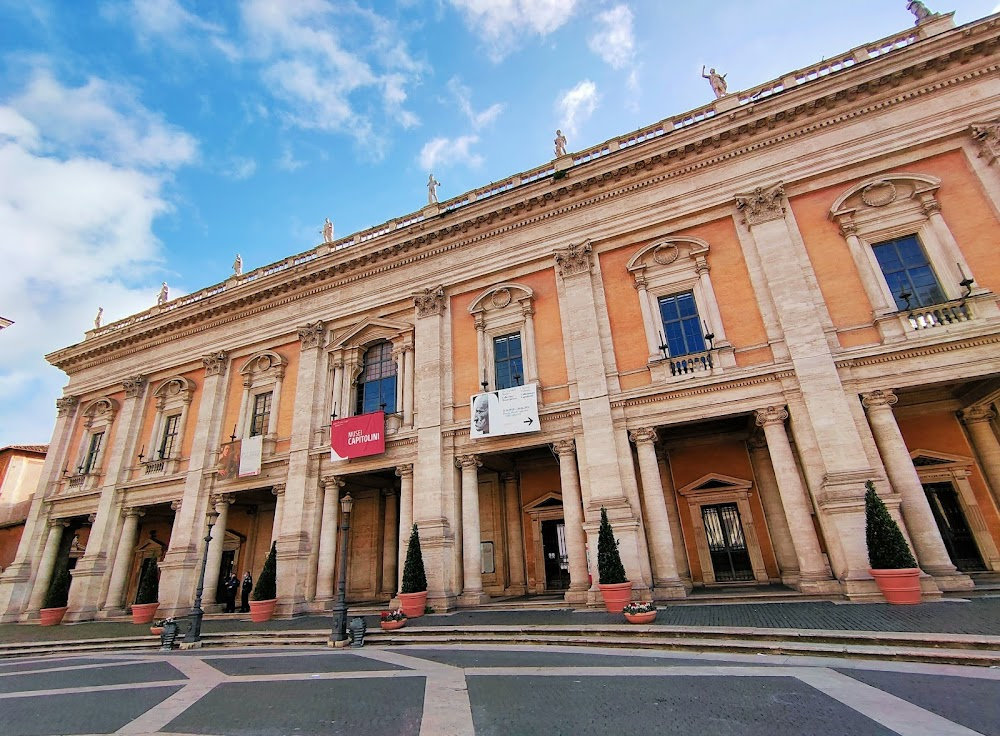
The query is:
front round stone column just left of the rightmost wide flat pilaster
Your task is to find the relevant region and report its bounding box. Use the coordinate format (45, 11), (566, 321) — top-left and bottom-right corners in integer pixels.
(755, 406), (839, 593)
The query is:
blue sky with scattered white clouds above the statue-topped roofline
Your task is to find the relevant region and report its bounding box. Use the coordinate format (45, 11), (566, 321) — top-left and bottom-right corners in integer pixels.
(0, 0), (998, 447)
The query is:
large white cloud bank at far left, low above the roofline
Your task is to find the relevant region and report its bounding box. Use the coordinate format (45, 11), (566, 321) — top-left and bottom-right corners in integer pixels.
(0, 71), (197, 446)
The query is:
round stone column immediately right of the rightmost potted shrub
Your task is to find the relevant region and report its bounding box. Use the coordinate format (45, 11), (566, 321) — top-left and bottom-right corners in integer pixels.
(861, 390), (972, 590)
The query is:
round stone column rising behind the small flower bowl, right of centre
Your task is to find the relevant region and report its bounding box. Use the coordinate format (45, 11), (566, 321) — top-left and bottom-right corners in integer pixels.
(629, 428), (687, 600)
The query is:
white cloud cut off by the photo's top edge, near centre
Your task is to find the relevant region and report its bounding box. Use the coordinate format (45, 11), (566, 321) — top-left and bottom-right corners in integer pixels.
(449, 0), (578, 61)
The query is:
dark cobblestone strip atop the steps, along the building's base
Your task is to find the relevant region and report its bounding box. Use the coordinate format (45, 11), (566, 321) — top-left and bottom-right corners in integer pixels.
(0, 597), (1000, 643)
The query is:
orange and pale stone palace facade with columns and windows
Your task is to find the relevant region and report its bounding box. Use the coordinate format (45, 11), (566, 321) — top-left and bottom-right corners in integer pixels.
(0, 15), (1000, 620)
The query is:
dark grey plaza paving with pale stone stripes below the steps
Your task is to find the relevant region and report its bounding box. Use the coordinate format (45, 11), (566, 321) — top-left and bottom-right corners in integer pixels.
(0, 646), (1000, 736)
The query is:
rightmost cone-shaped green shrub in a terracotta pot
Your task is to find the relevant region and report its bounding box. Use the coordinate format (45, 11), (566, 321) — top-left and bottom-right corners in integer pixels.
(865, 480), (920, 605)
